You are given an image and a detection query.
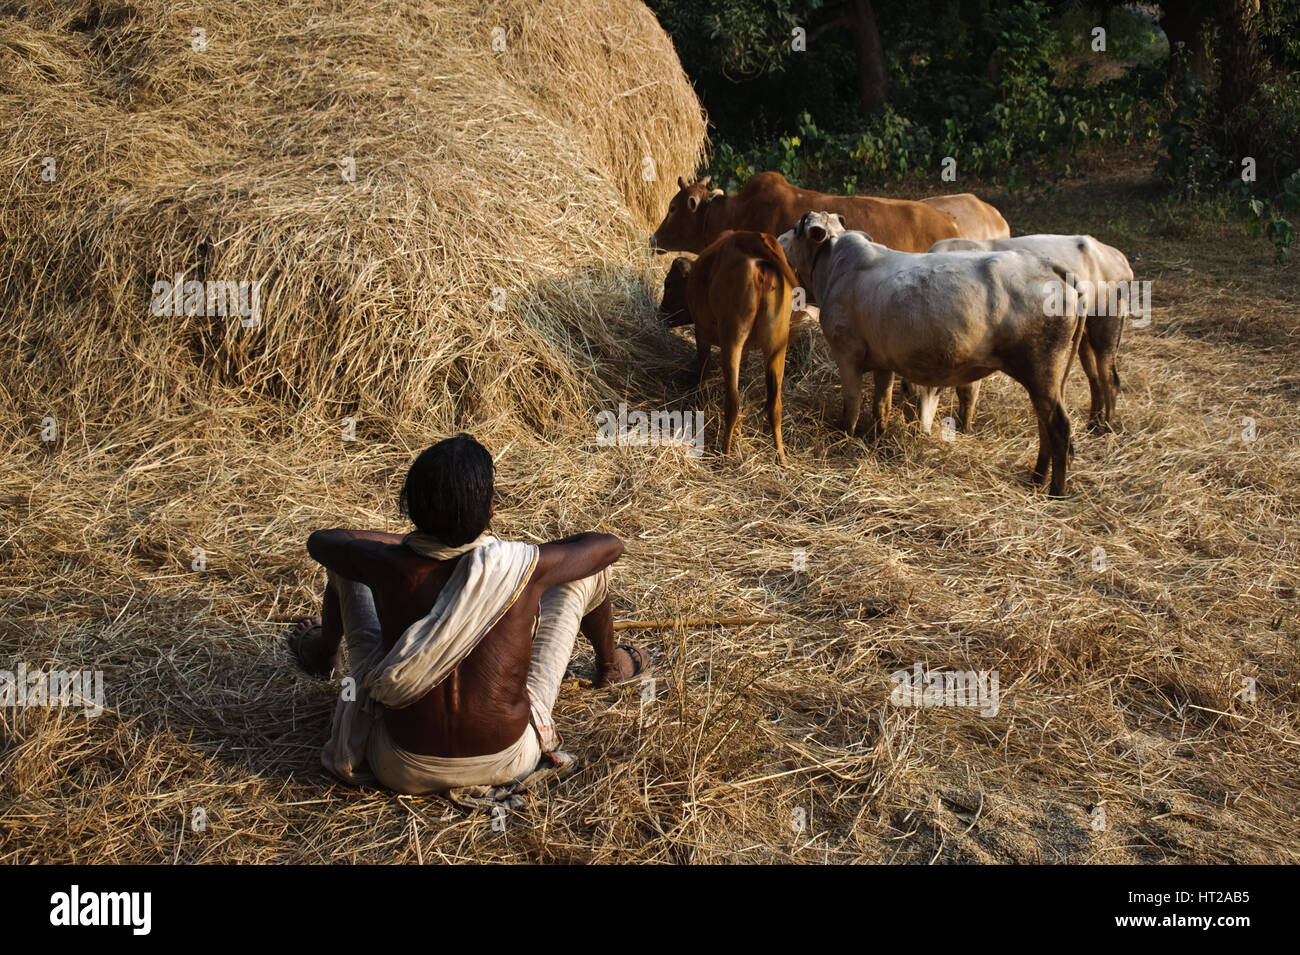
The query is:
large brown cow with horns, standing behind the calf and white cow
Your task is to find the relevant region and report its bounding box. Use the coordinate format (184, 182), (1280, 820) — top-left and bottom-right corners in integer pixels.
(650, 173), (962, 252)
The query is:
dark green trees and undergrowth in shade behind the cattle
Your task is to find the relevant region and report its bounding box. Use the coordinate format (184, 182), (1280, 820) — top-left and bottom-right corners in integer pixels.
(660, 0), (1300, 253)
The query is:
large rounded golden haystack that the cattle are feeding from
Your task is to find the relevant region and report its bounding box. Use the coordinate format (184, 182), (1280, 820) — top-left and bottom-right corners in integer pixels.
(0, 0), (703, 427)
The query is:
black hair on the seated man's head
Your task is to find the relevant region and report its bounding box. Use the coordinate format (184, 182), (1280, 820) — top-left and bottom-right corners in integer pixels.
(402, 434), (494, 547)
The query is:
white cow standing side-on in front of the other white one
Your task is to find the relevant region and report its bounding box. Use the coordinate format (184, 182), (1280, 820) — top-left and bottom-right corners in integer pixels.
(780, 212), (1083, 495)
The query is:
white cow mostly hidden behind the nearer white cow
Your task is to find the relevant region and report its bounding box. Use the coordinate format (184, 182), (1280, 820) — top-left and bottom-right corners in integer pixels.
(919, 235), (1134, 431)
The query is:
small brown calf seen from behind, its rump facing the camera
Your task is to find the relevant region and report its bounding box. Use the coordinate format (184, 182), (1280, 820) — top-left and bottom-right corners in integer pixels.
(660, 230), (800, 464)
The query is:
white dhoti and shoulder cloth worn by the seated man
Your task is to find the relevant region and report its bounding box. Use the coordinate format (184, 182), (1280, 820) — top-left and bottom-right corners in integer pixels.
(321, 534), (610, 794)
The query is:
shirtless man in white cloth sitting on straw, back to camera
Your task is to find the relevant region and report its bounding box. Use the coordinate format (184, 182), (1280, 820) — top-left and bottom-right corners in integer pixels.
(290, 434), (649, 794)
